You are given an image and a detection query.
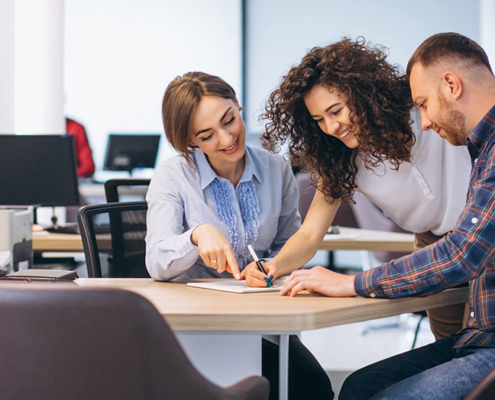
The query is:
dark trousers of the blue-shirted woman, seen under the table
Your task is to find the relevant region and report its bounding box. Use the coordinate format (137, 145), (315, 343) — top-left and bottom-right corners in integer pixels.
(262, 336), (334, 400)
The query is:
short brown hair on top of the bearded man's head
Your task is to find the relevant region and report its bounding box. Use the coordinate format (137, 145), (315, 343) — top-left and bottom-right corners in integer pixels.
(406, 32), (493, 78)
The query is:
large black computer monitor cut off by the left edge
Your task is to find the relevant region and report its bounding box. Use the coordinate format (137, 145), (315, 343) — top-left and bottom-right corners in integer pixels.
(0, 135), (80, 207)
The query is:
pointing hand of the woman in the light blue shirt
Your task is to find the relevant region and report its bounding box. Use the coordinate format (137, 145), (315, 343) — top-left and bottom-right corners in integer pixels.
(191, 224), (241, 279)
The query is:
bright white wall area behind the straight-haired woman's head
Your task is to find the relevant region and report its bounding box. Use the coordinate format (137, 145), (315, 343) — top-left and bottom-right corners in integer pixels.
(64, 0), (241, 169)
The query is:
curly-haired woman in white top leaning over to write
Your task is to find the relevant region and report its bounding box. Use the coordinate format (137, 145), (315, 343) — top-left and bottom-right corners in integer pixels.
(247, 38), (471, 339)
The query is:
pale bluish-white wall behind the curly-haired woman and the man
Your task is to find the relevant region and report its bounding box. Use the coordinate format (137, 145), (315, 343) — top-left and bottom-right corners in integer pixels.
(245, 0), (482, 132)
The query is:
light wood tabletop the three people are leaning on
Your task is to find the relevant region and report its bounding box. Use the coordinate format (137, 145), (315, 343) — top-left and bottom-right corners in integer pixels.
(76, 278), (468, 333)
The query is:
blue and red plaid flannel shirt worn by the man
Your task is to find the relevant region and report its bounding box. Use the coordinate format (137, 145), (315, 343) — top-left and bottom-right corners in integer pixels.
(354, 106), (495, 347)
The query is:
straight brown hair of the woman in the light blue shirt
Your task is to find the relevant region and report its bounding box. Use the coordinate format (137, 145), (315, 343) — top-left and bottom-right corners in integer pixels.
(162, 72), (237, 165)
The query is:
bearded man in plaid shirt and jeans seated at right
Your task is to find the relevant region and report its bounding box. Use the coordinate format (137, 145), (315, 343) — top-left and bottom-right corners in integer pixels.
(281, 33), (495, 400)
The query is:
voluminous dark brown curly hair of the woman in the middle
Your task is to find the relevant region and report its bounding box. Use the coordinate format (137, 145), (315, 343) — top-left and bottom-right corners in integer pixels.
(260, 37), (415, 203)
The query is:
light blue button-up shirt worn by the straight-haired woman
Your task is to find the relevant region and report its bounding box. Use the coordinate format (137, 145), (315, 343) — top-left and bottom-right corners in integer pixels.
(146, 146), (301, 280)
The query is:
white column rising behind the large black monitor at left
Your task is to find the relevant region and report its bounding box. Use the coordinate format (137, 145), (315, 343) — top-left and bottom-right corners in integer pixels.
(14, 0), (65, 134)
